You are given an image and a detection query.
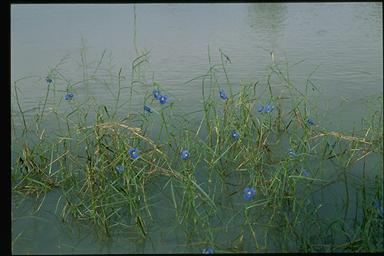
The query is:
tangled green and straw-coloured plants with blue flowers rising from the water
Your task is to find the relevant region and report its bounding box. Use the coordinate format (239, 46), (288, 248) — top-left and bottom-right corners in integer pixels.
(12, 47), (384, 254)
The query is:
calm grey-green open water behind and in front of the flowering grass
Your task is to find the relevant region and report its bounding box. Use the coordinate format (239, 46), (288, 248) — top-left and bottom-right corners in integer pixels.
(11, 3), (383, 254)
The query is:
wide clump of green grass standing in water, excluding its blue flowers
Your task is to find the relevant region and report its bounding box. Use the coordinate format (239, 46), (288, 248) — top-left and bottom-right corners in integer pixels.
(12, 47), (384, 252)
